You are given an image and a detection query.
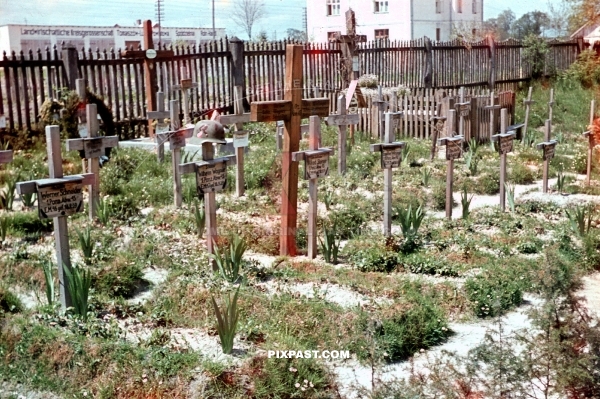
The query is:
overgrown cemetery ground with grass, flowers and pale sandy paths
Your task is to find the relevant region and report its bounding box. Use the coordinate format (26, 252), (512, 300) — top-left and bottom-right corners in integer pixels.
(0, 81), (600, 398)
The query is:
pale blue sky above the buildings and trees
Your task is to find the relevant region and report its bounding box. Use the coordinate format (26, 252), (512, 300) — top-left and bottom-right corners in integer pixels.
(0, 0), (560, 39)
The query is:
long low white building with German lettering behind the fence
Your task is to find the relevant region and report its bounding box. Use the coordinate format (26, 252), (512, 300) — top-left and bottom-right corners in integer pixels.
(0, 25), (225, 54)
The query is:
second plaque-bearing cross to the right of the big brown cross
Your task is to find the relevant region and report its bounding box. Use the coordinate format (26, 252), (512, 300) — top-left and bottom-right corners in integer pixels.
(370, 112), (405, 237)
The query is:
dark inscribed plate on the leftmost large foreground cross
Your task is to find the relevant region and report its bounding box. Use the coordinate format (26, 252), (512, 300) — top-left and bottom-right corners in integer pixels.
(37, 179), (83, 219)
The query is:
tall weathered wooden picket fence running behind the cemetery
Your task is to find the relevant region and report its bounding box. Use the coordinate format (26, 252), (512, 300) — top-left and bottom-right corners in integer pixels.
(0, 38), (582, 137)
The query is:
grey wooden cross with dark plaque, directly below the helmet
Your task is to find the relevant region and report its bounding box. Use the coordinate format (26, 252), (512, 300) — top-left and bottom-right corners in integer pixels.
(179, 142), (235, 269)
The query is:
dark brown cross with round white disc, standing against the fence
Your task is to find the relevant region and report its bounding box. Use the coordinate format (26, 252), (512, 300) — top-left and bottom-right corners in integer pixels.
(121, 19), (175, 137)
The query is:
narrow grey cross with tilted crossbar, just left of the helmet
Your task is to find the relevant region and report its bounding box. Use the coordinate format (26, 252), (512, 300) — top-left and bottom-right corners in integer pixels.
(156, 100), (194, 208)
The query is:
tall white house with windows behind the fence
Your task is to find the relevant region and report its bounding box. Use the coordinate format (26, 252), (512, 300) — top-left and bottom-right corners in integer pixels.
(307, 0), (483, 42)
